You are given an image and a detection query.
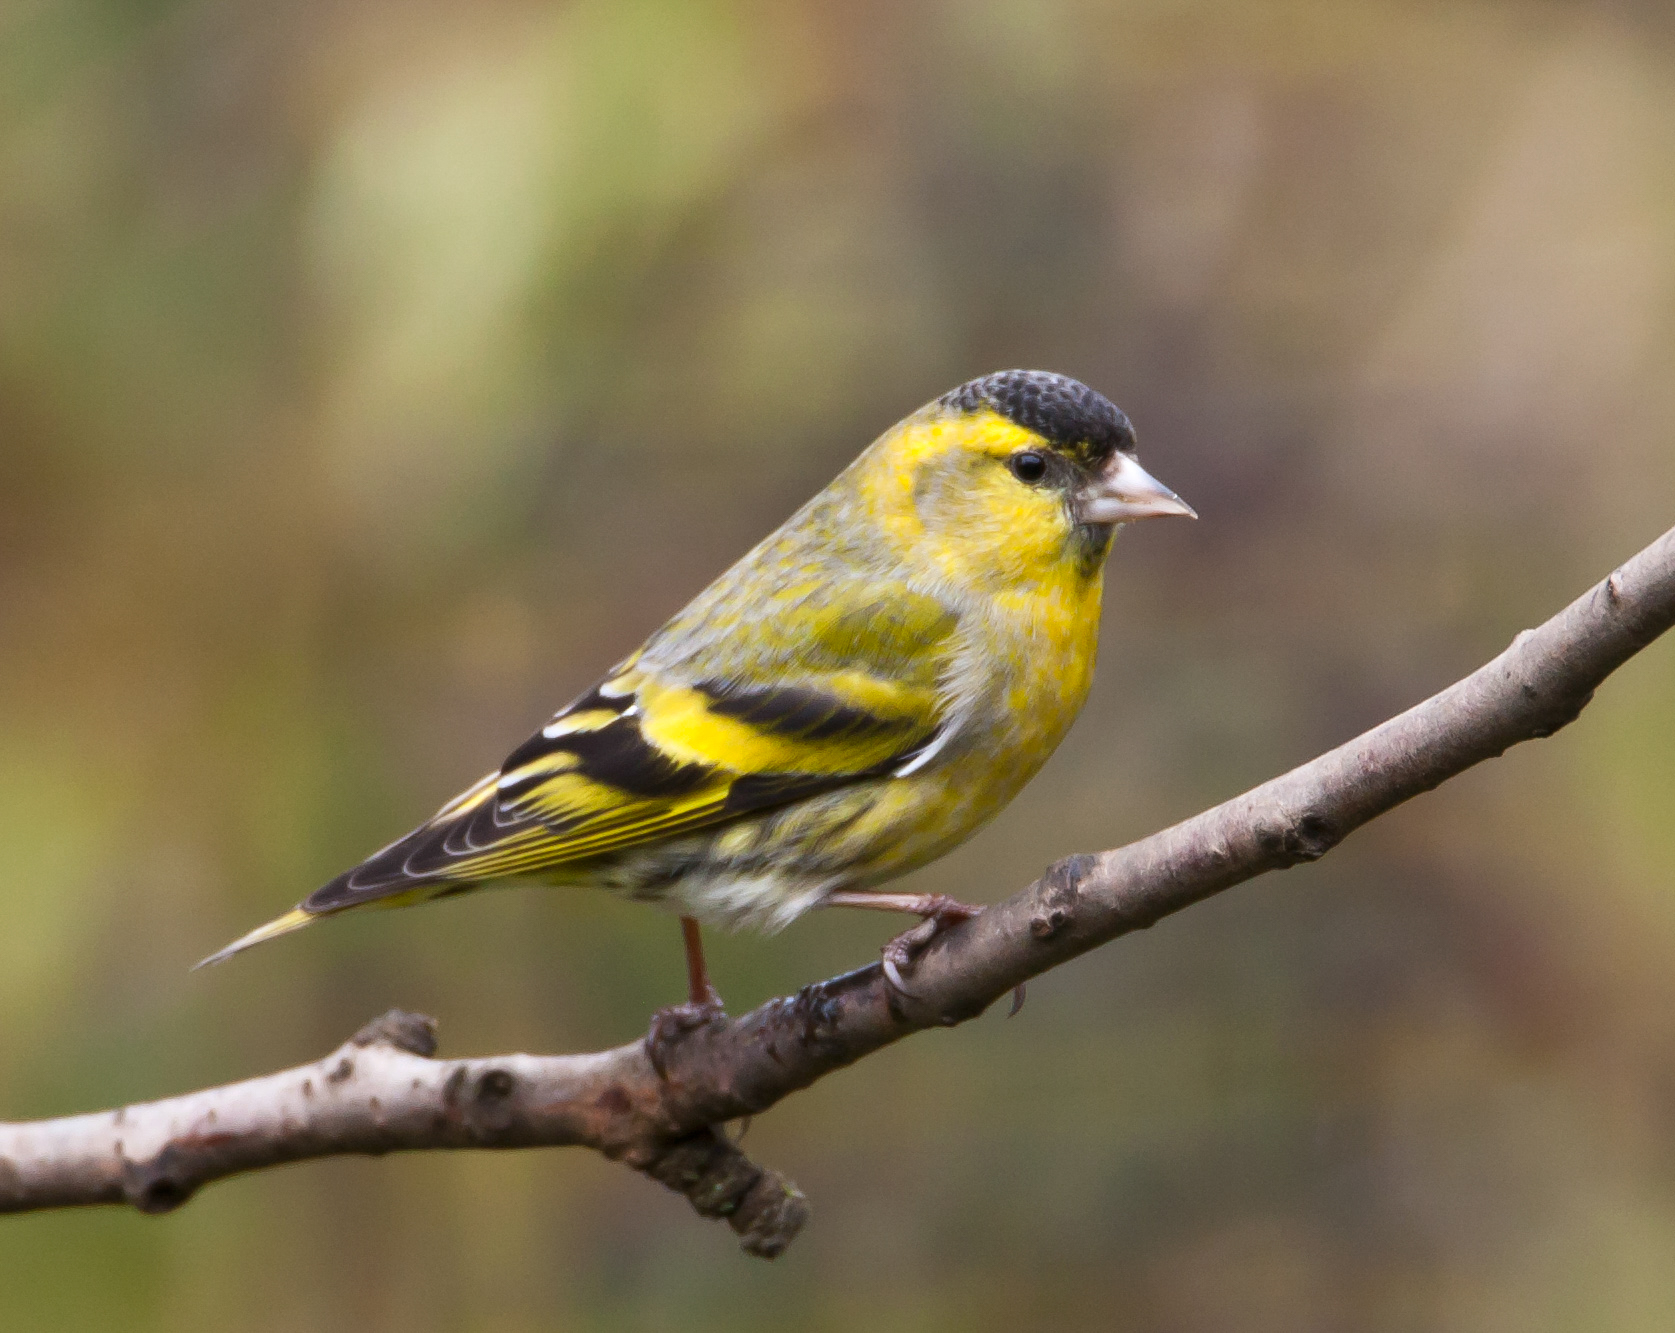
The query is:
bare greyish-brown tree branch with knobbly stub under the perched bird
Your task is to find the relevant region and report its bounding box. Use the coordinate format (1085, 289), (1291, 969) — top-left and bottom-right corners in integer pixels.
(0, 531), (1675, 1258)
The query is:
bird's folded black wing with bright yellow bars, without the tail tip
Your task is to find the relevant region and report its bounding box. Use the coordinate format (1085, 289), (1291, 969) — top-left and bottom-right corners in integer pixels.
(303, 658), (941, 913)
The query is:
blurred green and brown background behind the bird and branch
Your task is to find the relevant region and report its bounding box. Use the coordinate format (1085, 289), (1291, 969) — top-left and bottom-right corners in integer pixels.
(0, 0), (1675, 1333)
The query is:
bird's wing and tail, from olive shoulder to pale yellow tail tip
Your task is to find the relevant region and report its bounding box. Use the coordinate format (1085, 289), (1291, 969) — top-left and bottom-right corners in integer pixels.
(194, 589), (953, 963)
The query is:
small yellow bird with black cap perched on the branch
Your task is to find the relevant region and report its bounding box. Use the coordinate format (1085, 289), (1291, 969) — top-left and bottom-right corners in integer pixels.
(199, 370), (1196, 1006)
